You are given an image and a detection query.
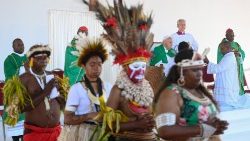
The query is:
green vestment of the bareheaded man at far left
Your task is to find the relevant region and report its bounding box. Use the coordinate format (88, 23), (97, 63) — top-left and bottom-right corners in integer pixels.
(3, 53), (27, 121)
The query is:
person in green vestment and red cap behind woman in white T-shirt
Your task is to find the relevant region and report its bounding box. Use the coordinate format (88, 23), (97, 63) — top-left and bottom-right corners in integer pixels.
(64, 26), (88, 86)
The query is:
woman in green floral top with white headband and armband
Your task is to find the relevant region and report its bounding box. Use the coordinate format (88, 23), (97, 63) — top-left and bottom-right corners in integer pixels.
(154, 50), (228, 141)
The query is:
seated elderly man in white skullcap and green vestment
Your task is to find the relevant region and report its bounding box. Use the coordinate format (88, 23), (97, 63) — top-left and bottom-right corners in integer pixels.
(150, 36), (176, 75)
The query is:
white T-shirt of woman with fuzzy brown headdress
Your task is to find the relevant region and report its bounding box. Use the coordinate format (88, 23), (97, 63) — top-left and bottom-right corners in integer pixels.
(66, 82), (111, 115)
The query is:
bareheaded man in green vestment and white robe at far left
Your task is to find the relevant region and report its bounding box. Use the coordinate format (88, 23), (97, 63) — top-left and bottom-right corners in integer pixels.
(3, 38), (27, 141)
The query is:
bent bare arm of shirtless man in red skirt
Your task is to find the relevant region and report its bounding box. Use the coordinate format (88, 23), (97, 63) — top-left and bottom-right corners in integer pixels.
(21, 75), (55, 112)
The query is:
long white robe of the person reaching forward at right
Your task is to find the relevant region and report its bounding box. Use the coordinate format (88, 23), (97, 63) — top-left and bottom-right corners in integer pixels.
(207, 52), (240, 106)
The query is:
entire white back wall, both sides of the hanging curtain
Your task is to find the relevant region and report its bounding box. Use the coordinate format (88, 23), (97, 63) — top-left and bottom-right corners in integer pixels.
(0, 0), (250, 80)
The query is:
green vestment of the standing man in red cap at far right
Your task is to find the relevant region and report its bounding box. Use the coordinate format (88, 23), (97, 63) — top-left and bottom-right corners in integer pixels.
(217, 38), (245, 95)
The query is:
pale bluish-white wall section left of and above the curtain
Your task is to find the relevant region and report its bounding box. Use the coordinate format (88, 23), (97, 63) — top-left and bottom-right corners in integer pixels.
(0, 0), (87, 80)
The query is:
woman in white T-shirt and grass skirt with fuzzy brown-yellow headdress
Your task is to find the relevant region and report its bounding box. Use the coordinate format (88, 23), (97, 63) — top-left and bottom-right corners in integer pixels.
(59, 40), (111, 141)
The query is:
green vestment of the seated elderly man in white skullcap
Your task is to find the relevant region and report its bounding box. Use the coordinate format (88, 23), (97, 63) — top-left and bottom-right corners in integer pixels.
(150, 44), (176, 66)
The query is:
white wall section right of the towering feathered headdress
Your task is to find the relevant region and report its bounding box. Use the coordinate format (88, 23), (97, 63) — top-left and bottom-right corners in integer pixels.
(139, 0), (250, 72)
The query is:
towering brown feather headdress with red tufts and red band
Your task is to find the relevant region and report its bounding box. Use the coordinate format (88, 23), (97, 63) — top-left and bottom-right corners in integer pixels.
(84, 0), (154, 65)
